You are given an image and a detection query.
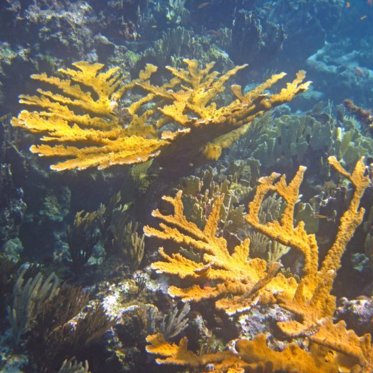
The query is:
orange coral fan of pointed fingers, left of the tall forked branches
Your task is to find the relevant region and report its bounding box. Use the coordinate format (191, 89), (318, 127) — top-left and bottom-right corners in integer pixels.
(144, 191), (296, 314)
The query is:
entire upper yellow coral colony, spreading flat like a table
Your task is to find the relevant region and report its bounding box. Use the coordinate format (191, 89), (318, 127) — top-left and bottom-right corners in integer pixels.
(12, 60), (309, 171)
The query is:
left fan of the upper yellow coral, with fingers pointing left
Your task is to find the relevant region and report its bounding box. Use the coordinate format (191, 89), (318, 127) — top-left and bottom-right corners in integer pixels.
(12, 62), (165, 171)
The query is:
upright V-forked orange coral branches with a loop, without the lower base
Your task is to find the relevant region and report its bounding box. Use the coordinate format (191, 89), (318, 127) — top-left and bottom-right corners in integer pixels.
(246, 157), (369, 335)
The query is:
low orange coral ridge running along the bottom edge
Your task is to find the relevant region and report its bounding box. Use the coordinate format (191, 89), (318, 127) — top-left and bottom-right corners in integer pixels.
(146, 334), (339, 373)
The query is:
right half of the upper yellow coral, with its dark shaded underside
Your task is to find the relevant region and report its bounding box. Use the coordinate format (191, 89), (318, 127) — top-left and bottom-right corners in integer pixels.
(139, 59), (310, 168)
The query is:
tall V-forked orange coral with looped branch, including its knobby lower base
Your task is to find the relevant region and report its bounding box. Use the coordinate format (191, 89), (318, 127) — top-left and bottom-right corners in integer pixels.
(246, 157), (369, 364)
